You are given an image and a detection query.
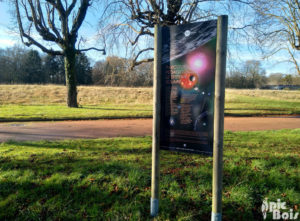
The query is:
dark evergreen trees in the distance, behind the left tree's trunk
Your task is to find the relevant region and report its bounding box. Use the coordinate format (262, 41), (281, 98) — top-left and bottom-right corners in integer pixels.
(0, 47), (92, 84)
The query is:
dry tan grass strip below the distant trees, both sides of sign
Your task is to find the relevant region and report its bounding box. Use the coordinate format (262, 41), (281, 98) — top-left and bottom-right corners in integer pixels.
(0, 85), (300, 105)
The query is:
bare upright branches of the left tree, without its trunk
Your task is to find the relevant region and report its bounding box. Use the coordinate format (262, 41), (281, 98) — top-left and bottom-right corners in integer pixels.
(14, 0), (105, 55)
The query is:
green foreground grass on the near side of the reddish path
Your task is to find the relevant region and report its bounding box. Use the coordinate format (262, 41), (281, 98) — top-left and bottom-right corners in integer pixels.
(0, 129), (300, 221)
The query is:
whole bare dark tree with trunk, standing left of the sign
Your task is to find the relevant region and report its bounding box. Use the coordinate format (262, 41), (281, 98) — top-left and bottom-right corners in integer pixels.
(14, 0), (105, 107)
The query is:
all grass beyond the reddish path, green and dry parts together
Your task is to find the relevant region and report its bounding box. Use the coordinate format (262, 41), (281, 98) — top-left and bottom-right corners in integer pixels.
(0, 85), (300, 122)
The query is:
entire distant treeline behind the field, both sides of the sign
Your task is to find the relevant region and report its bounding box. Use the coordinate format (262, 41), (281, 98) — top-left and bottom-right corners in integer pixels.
(0, 46), (300, 89)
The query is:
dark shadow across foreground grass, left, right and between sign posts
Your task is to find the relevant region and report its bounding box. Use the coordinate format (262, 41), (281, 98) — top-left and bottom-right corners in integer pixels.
(0, 156), (299, 220)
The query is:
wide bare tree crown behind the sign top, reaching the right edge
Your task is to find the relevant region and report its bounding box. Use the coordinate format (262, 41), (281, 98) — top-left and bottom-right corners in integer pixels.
(101, 0), (300, 73)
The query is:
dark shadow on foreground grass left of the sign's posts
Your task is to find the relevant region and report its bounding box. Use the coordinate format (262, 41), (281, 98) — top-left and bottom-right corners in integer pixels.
(0, 156), (154, 220)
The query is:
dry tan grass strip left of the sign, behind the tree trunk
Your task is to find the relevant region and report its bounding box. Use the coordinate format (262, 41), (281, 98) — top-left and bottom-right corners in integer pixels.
(0, 85), (152, 105)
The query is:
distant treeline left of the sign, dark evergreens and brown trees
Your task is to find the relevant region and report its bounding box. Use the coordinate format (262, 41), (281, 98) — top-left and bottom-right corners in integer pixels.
(0, 46), (152, 86)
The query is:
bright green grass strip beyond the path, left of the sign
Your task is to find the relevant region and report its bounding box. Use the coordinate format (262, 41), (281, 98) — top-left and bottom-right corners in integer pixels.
(0, 104), (152, 122)
